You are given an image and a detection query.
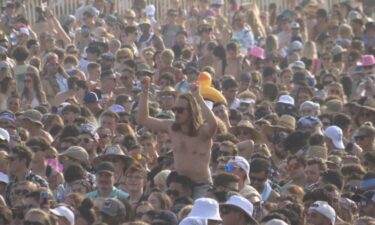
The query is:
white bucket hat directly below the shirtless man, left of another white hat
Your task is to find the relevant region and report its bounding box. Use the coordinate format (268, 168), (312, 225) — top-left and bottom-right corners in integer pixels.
(187, 198), (222, 221)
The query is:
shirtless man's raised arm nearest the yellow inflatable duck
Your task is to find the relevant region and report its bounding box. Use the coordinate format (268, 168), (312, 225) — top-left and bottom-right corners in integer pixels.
(190, 84), (217, 138)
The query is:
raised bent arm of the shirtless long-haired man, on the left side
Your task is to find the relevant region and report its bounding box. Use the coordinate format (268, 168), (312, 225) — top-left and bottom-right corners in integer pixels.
(136, 77), (169, 132)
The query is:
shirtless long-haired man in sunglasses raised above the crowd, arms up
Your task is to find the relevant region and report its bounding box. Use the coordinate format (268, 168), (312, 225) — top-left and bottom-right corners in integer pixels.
(137, 77), (217, 199)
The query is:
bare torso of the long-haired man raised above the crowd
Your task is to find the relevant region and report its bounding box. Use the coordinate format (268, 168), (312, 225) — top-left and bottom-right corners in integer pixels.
(168, 124), (212, 183)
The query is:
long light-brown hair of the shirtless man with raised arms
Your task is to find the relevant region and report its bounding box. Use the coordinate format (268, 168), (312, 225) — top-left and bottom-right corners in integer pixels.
(172, 93), (203, 137)
